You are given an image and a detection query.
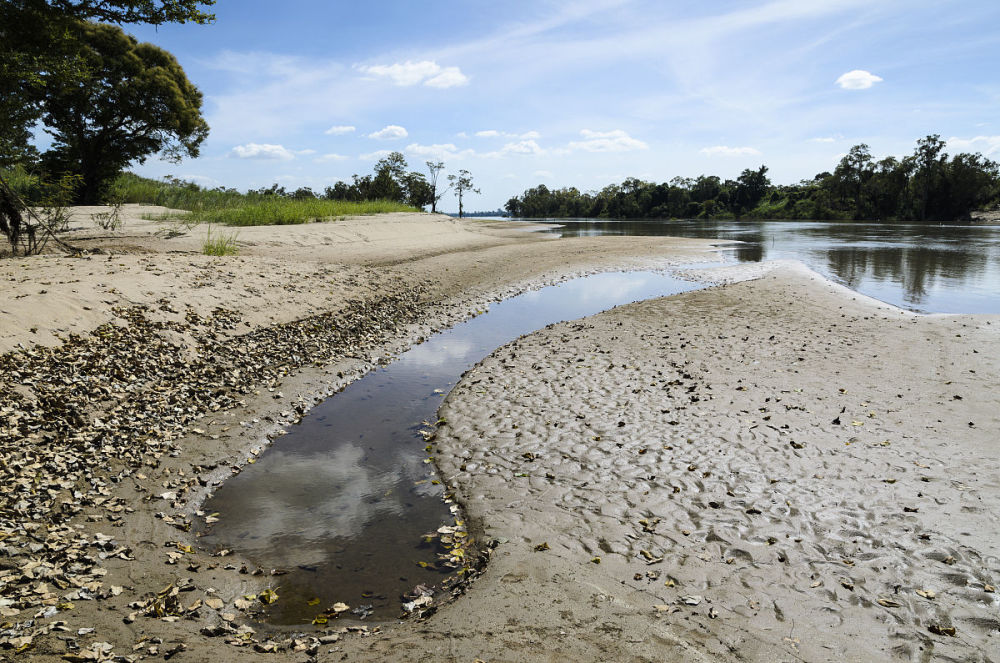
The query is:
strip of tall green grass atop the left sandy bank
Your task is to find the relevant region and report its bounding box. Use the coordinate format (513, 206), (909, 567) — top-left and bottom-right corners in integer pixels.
(110, 173), (419, 226)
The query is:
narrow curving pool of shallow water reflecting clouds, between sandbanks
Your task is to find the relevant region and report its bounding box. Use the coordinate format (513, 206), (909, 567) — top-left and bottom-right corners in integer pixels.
(201, 272), (701, 624)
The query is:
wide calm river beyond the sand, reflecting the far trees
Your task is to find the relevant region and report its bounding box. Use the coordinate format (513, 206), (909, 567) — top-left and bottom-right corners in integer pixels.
(534, 219), (1000, 313)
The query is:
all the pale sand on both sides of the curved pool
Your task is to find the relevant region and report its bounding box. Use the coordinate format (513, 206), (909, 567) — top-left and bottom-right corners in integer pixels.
(0, 209), (1000, 661)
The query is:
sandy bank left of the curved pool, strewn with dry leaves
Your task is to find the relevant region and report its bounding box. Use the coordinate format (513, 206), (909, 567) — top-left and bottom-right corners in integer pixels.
(0, 207), (711, 660)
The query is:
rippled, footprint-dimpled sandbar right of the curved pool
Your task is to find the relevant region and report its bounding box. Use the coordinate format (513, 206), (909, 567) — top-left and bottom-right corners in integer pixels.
(390, 266), (1000, 661)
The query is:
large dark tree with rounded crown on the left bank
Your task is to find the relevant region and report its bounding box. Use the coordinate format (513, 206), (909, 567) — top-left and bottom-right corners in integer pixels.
(41, 23), (208, 205)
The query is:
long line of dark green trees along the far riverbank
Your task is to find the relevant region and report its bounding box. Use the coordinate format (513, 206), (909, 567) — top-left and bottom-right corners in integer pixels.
(504, 135), (1000, 222)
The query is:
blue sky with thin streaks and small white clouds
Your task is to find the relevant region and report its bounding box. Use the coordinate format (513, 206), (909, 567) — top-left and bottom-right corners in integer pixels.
(128, 0), (1000, 210)
